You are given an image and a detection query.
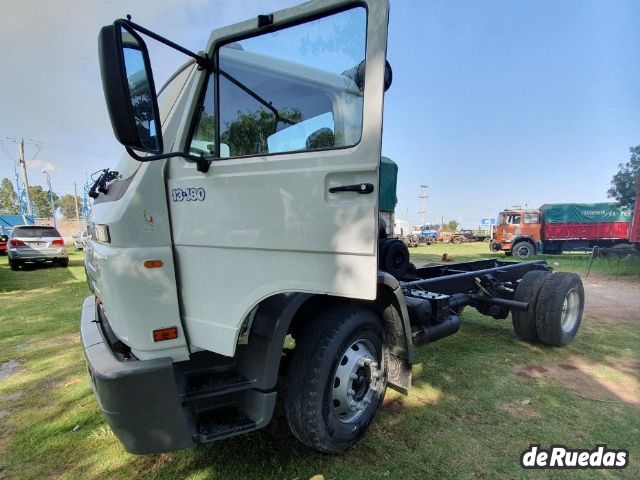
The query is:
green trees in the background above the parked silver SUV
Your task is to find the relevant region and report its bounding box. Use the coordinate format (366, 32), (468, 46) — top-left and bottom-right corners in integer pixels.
(0, 178), (82, 219)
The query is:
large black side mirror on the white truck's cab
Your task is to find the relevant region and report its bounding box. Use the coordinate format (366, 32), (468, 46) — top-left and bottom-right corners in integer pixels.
(98, 20), (163, 154)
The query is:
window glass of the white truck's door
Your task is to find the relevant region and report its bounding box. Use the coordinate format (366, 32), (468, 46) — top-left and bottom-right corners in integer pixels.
(190, 7), (366, 157)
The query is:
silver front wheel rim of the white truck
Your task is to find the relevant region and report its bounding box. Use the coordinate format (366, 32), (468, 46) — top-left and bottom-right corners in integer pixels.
(331, 339), (382, 423)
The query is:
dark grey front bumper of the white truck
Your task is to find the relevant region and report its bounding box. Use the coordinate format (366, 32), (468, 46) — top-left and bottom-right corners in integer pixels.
(80, 296), (193, 454)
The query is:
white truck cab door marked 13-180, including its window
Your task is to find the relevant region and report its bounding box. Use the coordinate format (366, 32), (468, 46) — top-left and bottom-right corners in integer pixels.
(167, 0), (388, 355)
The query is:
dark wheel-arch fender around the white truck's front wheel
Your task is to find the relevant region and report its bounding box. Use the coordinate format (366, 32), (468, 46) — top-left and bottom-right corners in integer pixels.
(236, 272), (413, 393)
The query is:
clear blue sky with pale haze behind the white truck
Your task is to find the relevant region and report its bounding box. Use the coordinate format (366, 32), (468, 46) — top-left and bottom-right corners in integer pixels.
(0, 0), (640, 227)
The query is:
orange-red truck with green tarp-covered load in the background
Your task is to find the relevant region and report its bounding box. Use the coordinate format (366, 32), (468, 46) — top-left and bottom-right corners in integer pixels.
(491, 202), (640, 258)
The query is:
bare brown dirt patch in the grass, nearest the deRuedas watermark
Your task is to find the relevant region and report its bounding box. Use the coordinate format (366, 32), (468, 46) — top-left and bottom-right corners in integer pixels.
(512, 356), (640, 405)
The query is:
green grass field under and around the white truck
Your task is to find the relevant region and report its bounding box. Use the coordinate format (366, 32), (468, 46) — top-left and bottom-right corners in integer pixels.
(0, 244), (640, 480)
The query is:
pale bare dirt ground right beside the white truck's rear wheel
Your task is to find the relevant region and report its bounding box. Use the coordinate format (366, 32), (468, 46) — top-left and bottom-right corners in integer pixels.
(582, 274), (640, 324)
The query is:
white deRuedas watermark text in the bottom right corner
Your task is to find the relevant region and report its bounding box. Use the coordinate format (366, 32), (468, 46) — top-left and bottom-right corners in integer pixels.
(520, 444), (629, 469)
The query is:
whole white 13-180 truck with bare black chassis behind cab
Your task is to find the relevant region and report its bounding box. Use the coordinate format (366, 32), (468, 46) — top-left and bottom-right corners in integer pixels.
(81, 0), (583, 453)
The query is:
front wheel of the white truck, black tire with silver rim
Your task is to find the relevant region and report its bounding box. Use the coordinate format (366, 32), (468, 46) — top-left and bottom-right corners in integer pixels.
(285, 304), (387, 453)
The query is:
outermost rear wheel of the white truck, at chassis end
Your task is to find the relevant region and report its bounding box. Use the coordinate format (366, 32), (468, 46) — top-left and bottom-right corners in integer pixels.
(536, 272), (584, 347)
